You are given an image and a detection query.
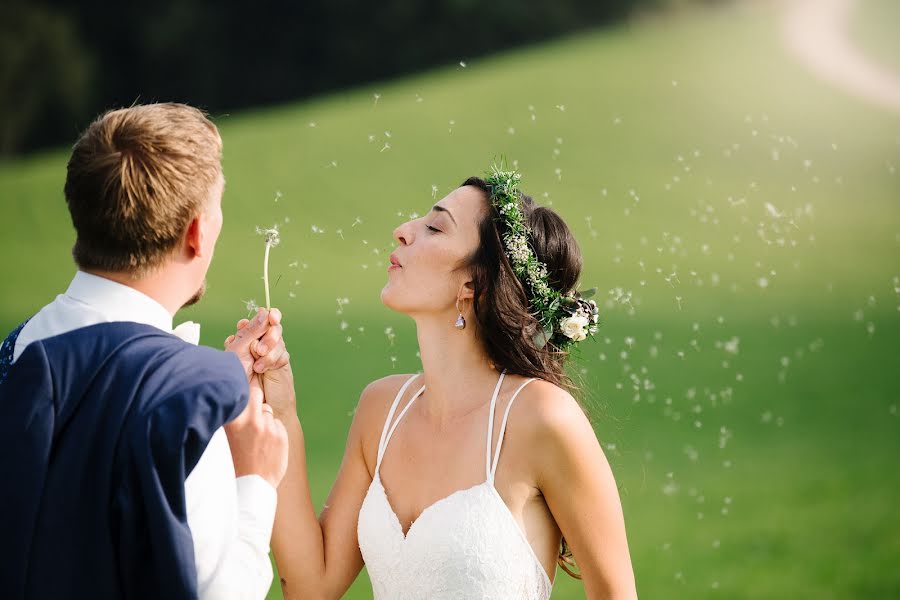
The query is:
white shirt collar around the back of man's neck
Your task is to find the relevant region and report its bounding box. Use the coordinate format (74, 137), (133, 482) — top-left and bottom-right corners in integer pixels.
(65, 271), (172, 332)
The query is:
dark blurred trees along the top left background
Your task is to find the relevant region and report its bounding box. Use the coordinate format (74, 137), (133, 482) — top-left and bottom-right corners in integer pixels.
(0, 0), (666, 153)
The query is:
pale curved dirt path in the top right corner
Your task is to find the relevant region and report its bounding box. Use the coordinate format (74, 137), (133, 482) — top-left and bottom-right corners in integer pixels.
(782, 0), (900, 114)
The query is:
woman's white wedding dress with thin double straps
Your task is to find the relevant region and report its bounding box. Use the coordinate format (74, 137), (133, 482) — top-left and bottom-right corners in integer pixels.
(357, 372), (552, 600)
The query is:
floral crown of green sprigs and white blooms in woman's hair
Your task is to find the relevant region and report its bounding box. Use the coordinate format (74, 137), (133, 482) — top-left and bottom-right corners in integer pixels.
(485, 164), (599, 349)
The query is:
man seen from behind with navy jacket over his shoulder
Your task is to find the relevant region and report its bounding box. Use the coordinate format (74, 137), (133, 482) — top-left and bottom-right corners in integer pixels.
(0, 104), (287, 599)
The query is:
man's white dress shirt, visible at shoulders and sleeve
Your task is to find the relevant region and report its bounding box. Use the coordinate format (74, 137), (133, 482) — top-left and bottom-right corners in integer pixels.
(13, 271), (277, 600)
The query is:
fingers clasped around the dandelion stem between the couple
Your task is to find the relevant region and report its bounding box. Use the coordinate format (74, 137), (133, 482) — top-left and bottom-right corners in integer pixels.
(225, 308), (290, 381)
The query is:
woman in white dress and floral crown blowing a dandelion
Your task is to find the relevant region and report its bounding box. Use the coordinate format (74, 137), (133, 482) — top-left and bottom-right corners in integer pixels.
(238, 168), (637, 600)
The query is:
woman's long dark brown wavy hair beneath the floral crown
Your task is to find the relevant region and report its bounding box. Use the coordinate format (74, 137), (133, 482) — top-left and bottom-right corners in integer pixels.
(462, 177), (582, 579)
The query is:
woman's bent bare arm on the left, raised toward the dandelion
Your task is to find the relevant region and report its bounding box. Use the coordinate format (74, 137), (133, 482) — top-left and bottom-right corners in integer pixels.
(265, 366), (400, 600)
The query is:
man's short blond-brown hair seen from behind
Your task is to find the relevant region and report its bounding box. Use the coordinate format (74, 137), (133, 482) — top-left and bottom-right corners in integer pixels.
(65, 103), (222, 276)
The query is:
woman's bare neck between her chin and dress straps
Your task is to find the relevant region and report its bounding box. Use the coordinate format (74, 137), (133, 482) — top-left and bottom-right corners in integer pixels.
(416, 318), (500, 423)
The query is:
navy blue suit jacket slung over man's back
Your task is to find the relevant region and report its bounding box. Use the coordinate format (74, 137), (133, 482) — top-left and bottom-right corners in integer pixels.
(0, 323), (248, 599)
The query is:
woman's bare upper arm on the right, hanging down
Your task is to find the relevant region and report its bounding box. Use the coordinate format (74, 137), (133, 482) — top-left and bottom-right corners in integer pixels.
(523, 381), (637, 600)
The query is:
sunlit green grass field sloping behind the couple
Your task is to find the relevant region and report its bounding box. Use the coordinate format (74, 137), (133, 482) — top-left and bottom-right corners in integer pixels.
(0, 3), (900, 600)
